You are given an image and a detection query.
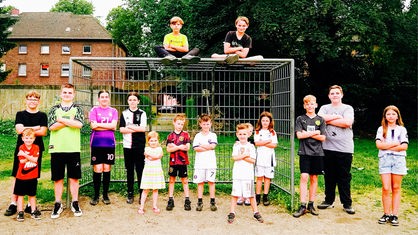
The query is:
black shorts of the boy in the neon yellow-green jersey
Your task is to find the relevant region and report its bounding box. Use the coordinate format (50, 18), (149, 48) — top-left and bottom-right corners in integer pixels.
(51, 152), (81, 181)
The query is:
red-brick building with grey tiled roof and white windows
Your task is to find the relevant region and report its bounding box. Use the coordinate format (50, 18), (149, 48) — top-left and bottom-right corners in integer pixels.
(1, 12), (126, 85)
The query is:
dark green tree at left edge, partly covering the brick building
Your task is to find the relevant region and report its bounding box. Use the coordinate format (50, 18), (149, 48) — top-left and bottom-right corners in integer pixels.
(0, 4), (17, 83)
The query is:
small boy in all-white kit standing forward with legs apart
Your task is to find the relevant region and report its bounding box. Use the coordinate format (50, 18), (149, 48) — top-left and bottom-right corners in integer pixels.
(228, 123), (264, 223)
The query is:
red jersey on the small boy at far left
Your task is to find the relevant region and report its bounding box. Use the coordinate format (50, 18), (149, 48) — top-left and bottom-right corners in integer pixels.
(16, 144), (39, 180)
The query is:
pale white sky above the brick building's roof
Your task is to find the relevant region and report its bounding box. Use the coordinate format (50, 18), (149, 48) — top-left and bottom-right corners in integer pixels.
(0, 0), (124, 22)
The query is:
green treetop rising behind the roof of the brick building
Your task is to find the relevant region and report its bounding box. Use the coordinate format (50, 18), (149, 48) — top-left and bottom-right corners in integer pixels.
(50, 0), (94, 15)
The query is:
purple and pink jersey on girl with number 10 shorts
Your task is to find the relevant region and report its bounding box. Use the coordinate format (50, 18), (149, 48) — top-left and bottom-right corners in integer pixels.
(89, 107), (119, 148)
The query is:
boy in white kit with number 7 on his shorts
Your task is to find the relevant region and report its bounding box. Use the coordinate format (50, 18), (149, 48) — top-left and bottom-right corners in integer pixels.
(193, 114), (218, 211)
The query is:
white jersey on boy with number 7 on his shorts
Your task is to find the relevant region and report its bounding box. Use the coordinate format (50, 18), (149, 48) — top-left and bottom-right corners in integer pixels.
(193, 132), (218, 169)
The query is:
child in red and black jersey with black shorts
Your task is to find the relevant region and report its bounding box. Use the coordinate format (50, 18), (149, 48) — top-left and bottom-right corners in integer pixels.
(166, 114), (192, 211)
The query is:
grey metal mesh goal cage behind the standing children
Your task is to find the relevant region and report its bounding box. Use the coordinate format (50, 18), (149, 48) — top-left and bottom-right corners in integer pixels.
(70, 57), (294, 204)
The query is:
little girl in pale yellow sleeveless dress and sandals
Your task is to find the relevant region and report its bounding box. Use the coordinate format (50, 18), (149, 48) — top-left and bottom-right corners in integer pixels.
(138, 131), (165, 214)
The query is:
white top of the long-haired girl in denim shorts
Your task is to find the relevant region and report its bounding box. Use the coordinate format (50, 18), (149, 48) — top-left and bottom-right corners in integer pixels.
(376, 125), (409, 157)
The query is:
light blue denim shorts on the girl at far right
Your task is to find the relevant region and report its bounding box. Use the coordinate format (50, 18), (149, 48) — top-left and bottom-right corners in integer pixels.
(379, 153), (408, 175)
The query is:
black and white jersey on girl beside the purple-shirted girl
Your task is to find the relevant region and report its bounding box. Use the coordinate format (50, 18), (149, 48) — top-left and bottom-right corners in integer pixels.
(119, 109), (147, 149)
